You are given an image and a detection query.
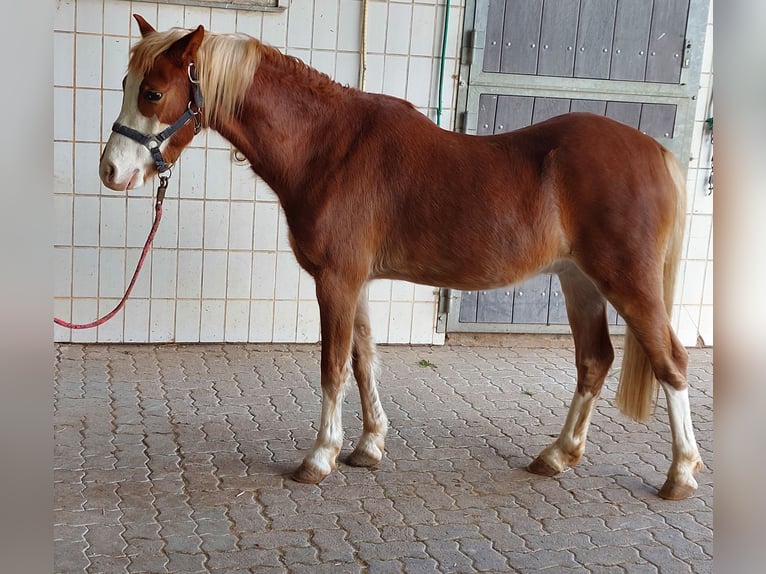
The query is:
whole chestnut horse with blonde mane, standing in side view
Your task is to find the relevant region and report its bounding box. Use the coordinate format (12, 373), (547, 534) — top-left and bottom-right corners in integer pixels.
(99, 16), (702, 499)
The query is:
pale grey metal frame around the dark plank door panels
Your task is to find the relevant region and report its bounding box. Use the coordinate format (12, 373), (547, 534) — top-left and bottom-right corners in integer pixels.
(437, 0), (709, 333)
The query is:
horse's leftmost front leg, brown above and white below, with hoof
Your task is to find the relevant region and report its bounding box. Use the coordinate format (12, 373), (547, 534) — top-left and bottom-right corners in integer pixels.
(293, 273), (359, 484)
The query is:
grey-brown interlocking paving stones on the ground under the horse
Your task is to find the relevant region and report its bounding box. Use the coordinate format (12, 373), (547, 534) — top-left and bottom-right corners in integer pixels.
(54, 344), (713, 574)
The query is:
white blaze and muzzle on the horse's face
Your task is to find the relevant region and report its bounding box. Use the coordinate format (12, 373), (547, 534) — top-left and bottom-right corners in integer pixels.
(99, 73), (168, 191)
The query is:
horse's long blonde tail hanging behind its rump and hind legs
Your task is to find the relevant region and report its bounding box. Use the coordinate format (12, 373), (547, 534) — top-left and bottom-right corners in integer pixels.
(615, 149), (686, 421)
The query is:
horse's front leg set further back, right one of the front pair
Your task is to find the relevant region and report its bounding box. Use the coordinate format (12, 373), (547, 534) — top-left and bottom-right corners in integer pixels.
(346, 289), (388, 466)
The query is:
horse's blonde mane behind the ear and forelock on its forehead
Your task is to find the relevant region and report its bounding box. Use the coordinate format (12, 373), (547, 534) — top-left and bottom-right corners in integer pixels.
(128, 28), (265, 124)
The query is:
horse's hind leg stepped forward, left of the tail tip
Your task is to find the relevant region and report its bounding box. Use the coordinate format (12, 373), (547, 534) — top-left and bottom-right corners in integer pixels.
(527, 264), (614, 476)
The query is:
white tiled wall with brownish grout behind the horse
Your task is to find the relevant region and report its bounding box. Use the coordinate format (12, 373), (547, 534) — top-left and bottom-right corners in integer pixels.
(54, 0), (712, 344)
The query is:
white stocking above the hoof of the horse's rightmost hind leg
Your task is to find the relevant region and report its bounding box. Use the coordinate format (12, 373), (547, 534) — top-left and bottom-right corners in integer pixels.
(660, 381), (702, 489)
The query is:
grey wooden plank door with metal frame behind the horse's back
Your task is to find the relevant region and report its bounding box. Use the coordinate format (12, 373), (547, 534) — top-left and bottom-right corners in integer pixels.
(440, 0), (708, 332)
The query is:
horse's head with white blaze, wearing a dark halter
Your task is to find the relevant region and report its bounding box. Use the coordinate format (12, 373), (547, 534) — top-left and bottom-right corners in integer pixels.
(99, 15), (205, 191)
